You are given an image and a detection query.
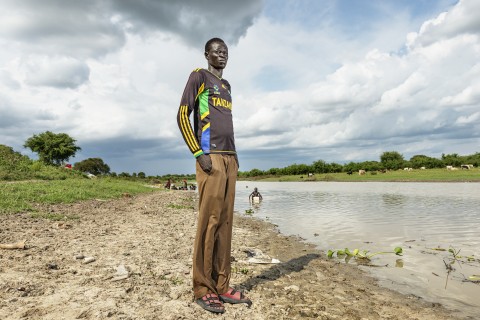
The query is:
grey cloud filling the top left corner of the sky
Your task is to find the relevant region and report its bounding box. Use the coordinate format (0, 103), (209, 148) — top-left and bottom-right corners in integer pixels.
(0, 0), (125, 58)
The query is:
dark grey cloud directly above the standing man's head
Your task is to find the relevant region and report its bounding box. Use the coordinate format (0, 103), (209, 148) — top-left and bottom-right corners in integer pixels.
(111, 0), (263, 47)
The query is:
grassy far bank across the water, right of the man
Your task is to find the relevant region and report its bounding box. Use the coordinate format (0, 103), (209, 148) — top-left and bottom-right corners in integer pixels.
(247, 168), (480, 182)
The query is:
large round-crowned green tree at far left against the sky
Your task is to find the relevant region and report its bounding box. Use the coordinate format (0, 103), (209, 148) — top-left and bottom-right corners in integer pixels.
(23, 131), (81, 166)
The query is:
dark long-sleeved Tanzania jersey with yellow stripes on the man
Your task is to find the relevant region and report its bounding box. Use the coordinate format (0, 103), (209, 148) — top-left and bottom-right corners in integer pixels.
(177, 69), (236, 157)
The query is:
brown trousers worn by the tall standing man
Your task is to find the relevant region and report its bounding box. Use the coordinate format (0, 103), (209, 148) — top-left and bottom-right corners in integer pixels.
(193, 154), (238, 299)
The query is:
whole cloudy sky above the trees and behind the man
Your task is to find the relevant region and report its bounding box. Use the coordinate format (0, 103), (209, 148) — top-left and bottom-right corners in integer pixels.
(0, 0), (480, 175)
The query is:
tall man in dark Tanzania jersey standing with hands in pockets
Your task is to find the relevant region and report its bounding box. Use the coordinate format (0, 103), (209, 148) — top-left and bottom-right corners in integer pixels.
(177, 38), (251, 313)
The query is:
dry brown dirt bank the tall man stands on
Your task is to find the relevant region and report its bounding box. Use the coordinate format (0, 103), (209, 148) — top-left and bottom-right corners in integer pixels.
(0, 191), (468, 320)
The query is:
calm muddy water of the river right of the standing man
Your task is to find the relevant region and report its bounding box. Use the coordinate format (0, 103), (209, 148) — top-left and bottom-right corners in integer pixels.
(235, 181), (480, 315)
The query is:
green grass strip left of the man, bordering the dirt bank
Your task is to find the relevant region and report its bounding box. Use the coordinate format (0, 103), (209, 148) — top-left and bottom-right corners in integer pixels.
(0, 178), (162, 214)
